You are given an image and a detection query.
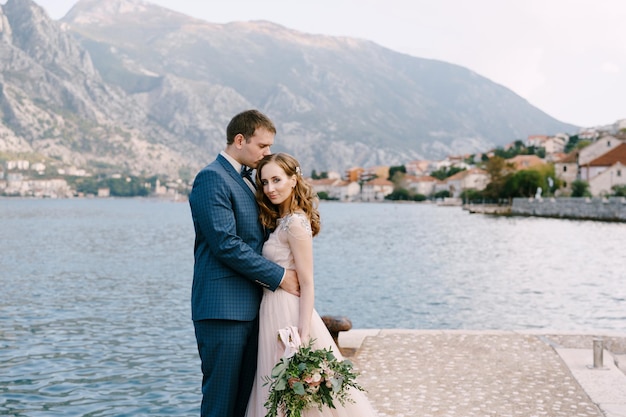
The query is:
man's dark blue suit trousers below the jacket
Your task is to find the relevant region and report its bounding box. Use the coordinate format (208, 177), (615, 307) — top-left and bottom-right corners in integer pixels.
(194, 316), (259, 417)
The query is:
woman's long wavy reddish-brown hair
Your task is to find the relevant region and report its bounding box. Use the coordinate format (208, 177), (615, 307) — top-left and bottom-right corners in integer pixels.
(256, 153), (321, 236)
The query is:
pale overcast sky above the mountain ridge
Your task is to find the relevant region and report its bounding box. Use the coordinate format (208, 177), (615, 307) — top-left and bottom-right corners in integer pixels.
(22, 0), (626, 127)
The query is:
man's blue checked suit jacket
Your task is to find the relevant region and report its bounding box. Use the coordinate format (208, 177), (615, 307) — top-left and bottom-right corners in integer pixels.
(189, 155), (285, 320)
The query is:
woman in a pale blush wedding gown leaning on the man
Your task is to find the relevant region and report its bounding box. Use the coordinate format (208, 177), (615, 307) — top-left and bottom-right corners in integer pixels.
(246, 153), (375, 417)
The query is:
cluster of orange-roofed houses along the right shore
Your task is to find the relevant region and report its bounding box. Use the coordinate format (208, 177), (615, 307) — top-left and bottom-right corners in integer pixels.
(311, 126), (626, 202)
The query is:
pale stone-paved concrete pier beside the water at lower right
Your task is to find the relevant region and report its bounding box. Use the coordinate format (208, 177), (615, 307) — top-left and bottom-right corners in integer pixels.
(339, 329), (626, 417)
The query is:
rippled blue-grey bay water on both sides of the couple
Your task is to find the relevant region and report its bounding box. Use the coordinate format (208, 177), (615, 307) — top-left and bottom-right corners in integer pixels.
(0, 199), (626, 416)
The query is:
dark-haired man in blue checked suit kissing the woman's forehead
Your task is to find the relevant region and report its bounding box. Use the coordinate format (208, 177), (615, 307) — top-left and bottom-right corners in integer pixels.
(189, 110), (299, 417)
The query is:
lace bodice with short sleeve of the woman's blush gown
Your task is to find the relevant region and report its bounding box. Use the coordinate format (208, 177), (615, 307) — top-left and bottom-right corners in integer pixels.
(263, 213), (313, 269)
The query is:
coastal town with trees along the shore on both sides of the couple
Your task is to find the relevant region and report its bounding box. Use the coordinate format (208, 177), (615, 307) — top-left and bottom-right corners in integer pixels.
(0, 119), (626, 204)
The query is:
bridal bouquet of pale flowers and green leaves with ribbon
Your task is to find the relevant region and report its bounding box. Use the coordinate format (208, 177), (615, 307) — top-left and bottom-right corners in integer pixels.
(264, 328), (363, 417)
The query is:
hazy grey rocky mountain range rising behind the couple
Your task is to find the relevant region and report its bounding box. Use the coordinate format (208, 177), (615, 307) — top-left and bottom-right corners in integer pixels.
(0, 0), (577, 176)
